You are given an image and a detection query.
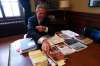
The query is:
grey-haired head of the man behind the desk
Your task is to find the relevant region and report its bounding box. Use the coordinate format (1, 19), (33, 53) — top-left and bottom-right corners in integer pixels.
(36, 4), (46, 20)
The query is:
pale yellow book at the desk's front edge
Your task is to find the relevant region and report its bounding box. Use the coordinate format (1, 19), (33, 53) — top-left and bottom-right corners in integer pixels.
(29, 50), (48, 66)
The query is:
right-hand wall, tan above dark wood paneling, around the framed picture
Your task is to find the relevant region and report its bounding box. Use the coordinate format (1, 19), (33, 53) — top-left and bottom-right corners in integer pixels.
(69, 0), (100, 33)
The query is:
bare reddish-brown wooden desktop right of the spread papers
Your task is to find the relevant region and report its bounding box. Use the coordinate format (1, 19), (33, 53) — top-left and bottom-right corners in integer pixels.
(66, 43), (100, 66)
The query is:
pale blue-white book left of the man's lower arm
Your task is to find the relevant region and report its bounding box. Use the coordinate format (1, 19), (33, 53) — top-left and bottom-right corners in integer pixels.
(16, 38), (37, 54)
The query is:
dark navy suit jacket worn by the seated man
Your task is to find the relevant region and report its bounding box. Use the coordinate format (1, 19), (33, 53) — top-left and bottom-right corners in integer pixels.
(27, 16), (57, 43)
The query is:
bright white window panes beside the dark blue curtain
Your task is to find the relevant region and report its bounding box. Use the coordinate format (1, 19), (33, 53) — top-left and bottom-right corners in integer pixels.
(0, 0), (21, 17)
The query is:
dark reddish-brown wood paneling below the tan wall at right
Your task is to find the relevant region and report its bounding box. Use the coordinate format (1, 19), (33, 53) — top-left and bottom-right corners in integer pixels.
(70, 11), (100, 32)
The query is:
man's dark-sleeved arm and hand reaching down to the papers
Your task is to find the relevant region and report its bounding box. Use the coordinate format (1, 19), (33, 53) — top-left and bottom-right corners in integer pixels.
(27, 18), (50, 52)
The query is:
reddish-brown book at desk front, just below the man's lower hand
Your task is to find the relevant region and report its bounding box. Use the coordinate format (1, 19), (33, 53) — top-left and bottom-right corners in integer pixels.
(47, 46), (65, 66)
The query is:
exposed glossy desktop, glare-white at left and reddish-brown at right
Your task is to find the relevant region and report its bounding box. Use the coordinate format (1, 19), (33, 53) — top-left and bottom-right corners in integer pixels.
(0, 40), (100, 66)
